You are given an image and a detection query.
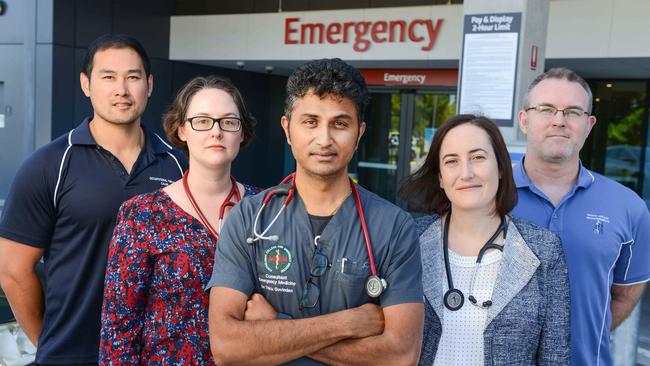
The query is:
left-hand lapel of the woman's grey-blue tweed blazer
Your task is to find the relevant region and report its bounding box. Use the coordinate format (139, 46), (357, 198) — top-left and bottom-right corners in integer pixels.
(420, 218), (446, 321)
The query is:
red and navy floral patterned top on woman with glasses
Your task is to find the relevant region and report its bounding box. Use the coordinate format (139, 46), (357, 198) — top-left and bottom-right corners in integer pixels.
(99, 185), (260, 365)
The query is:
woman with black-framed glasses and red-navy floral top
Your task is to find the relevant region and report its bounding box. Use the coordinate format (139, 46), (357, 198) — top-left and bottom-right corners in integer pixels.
(100, 76), (259, 365)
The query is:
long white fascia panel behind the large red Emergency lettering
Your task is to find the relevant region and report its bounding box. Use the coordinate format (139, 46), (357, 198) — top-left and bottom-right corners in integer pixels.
(169, 5), (463, 60)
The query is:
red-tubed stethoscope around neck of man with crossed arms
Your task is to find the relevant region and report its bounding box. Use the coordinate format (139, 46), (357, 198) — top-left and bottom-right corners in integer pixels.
(246, 173), (388, 297)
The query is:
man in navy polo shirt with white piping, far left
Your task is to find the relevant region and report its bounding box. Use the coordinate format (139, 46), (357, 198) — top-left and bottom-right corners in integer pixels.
(0, 34), (186, 365)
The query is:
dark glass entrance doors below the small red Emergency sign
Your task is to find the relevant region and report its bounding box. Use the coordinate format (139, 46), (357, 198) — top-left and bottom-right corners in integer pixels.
(356, 90), (456, 207)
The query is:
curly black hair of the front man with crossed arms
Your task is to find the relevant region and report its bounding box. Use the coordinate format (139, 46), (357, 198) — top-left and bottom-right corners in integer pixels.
(284, 58), (370, 123)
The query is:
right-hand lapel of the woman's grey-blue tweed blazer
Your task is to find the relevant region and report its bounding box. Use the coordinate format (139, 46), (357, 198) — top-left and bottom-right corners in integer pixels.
(485, 221), (540, 327)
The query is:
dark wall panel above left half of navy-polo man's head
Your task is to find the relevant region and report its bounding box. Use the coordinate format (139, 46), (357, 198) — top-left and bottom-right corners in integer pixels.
(74, 0), (113, 48)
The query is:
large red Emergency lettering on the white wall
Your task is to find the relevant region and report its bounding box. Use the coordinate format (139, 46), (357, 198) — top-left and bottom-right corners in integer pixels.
(284, 18), (443, 52)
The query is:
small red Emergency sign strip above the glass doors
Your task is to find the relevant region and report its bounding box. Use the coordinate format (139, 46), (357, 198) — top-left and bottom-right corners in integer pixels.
(360, 69), (458, 88)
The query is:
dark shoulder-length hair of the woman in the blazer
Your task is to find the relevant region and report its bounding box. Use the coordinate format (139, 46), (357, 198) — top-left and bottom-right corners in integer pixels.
(400, 114), (517, 215)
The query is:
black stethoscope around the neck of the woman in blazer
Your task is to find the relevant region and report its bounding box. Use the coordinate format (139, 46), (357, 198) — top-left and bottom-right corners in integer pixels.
(442, 209), (508, 311)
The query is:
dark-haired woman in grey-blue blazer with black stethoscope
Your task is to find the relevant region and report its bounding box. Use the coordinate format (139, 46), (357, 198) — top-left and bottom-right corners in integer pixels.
(401, 115), (570, 366)
